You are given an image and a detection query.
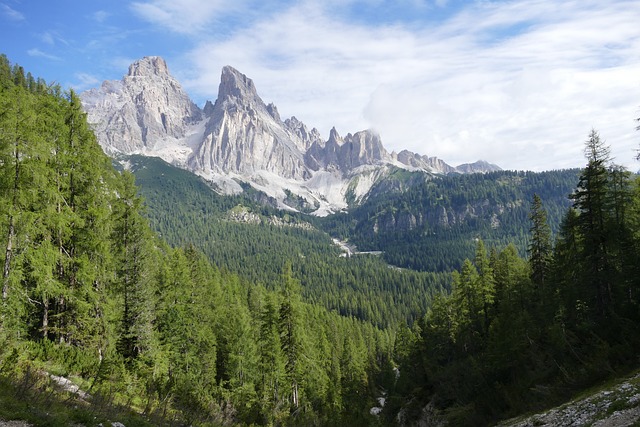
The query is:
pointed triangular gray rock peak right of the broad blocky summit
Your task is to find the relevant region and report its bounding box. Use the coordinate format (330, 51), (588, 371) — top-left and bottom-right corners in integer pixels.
(189, 66), (311, 180)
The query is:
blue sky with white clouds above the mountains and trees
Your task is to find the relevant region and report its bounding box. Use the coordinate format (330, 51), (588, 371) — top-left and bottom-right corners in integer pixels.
(0, 0), (640, 171)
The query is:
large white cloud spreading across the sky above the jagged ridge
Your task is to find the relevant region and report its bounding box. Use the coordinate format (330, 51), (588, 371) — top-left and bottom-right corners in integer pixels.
(170, 0), (640, 170)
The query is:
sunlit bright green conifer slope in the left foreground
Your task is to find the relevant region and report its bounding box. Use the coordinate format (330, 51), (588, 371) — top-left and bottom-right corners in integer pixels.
(0, 56), (392, 425)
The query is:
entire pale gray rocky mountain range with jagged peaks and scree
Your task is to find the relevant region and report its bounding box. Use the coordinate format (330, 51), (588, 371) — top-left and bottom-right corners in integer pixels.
(81, 57), (500, 216)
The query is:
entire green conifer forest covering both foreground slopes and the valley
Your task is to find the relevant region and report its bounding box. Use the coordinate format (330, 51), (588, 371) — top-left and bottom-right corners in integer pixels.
(0, 55), (640, 427)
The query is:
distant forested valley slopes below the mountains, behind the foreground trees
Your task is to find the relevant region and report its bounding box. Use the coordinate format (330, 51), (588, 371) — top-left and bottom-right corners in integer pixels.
(125, 156), (578, 326)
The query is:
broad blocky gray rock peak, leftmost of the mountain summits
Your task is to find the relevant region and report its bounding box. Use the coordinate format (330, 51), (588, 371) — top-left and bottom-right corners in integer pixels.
(80, 57), (202, 154)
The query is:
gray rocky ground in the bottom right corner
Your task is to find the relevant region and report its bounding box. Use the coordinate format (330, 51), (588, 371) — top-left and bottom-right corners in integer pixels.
(498, 373), (640, 427)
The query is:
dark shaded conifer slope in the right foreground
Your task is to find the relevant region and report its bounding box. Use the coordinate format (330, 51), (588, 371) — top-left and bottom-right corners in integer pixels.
(390, 131), (640, 425)
